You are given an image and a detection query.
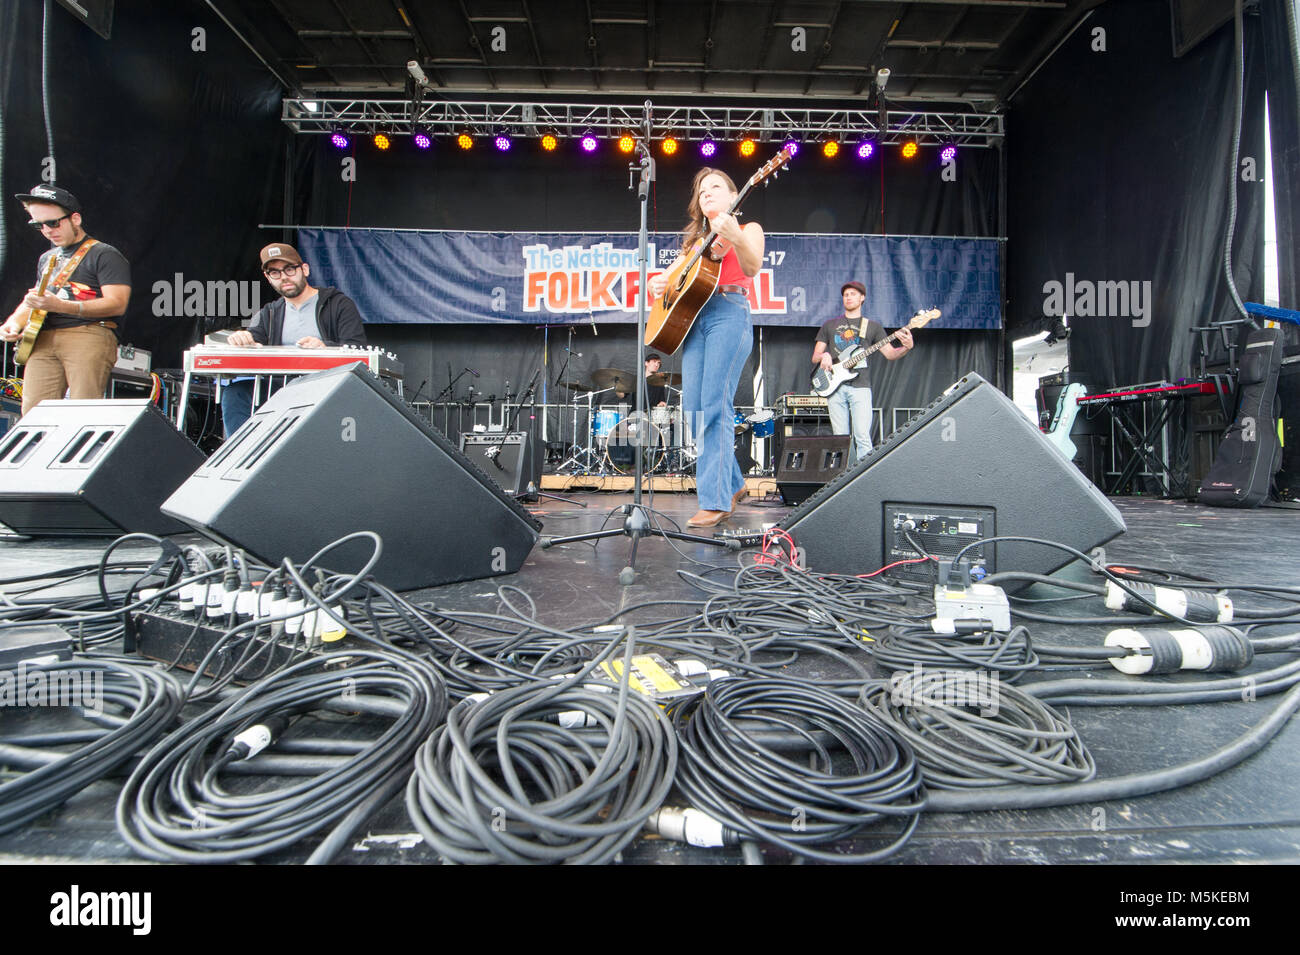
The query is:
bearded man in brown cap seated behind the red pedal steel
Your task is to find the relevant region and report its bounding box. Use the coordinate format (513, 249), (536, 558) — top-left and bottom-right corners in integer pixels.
(221, 242), (365, 438)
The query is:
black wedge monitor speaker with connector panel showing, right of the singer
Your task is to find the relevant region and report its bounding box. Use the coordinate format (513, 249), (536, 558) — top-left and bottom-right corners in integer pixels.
(780, 374), (1126, 576)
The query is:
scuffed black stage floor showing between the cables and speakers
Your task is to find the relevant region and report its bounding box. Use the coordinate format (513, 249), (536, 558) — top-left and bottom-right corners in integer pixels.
(0, 494), (1300, 864)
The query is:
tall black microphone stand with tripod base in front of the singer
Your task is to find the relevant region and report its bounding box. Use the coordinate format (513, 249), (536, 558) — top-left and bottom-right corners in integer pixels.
(541, 100), (741, 586)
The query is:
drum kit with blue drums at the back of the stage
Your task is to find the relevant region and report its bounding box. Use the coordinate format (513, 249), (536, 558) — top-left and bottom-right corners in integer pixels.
(556, 368), (776, 476)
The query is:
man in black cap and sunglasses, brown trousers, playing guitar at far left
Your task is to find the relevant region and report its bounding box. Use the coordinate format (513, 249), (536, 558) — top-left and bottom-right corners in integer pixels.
(0, 185), (131, 414)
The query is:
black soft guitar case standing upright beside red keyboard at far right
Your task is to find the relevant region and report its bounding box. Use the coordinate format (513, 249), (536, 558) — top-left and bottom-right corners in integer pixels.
(1196, 329), (1282, 507)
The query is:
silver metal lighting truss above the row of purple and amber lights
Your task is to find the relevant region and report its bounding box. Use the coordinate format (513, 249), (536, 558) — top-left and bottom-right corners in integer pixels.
(281, 96), (1005, 147)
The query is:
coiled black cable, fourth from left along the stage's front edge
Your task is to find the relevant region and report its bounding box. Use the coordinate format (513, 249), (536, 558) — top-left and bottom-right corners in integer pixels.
(668, 680), (926, 863)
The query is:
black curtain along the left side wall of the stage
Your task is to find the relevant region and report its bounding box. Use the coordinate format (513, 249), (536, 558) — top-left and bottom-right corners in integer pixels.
(0, 0), (289, 368)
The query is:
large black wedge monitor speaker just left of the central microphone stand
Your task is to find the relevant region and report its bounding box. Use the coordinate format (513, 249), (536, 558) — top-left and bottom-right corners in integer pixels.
(163, 365), (541, 590)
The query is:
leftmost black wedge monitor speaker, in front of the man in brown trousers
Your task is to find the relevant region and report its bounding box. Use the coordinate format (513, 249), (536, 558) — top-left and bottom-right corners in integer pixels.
(0, 399), (203, 537)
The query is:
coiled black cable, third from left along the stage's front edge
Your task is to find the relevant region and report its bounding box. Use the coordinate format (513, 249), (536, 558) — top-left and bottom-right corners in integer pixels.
(406, 631), (677, 864)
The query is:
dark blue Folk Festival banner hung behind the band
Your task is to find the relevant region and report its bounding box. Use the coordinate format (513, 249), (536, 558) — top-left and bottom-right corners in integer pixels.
(298, 229), (1002, 329)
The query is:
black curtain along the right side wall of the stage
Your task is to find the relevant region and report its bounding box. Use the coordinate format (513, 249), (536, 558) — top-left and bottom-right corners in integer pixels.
(1008, 0), (1265, 390)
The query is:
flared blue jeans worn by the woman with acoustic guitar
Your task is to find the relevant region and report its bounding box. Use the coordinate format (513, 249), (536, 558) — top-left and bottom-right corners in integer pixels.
(681, 292), (754, 511)
